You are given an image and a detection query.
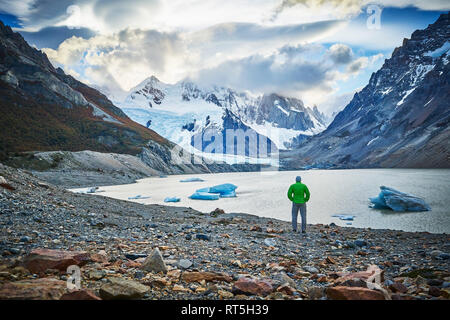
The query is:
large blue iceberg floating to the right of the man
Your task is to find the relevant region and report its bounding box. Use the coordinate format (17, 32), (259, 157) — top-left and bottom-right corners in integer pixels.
(369, 186), (431, 212)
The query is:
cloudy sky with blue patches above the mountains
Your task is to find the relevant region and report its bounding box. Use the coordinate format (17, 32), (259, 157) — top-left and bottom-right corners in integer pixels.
(0, 0), (450, 113)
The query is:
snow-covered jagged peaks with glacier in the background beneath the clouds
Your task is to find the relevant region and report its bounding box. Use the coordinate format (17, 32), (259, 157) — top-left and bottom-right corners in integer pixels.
(116, 76), (326, 156)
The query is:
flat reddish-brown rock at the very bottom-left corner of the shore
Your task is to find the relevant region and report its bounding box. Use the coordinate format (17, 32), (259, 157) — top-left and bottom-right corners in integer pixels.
(0, 278), (67, 300)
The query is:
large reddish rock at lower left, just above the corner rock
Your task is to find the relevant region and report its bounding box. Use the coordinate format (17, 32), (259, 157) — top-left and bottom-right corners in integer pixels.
(24, 249), (90, 273)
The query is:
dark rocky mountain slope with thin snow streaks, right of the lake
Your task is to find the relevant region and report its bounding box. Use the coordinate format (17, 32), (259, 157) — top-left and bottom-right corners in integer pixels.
(282, 14), (450, 168)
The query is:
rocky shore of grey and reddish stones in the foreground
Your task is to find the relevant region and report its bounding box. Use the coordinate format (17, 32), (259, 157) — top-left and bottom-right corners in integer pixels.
(0, 165), (450, 300)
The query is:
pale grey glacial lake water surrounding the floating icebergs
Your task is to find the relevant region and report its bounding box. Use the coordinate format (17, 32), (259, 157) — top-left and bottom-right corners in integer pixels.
(75, 169), (450, 234)
